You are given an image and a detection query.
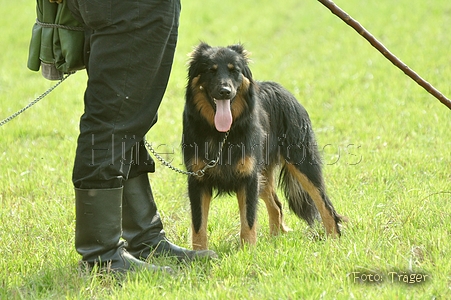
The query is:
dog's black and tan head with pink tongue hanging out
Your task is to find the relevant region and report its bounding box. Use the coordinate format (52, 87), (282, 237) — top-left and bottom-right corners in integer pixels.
(188, 43), (253, 132)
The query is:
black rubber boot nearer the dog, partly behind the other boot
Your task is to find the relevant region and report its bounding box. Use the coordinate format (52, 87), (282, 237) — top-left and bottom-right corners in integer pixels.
(122, 173), (218, 261)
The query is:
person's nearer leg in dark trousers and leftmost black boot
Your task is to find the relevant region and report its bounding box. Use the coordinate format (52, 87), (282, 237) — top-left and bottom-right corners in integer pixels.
(70, 0), (180, 270)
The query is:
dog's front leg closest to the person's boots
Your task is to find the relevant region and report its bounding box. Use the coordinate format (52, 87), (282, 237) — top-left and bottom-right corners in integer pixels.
(188, 179), (212, 250)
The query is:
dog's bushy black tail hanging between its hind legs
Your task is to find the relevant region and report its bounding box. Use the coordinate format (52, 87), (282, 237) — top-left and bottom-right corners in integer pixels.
(279, 165), (321, 225)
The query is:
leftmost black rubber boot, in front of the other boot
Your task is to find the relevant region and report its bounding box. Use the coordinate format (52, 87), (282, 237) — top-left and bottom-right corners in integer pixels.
(75, 188), (172, 273)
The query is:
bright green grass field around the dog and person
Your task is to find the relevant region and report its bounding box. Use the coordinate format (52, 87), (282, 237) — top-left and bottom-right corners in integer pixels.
(0, 0), (451, 300)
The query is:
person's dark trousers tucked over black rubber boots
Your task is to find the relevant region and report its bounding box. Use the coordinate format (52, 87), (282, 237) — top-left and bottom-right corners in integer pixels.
(69, 0), (180, 189)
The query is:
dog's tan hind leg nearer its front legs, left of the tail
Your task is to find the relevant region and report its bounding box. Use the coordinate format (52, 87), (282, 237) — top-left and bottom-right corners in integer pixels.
(260, 167), (292, 236)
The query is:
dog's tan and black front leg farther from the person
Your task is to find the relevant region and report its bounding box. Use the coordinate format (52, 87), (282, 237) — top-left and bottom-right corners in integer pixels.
(236, 180), (258, 245)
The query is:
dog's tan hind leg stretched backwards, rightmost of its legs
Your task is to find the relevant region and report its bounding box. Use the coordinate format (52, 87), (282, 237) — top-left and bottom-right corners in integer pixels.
(285, 163), (340, 237)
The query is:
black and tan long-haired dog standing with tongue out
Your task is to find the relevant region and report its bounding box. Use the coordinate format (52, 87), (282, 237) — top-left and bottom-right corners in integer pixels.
(182, 43), (341, 249)
